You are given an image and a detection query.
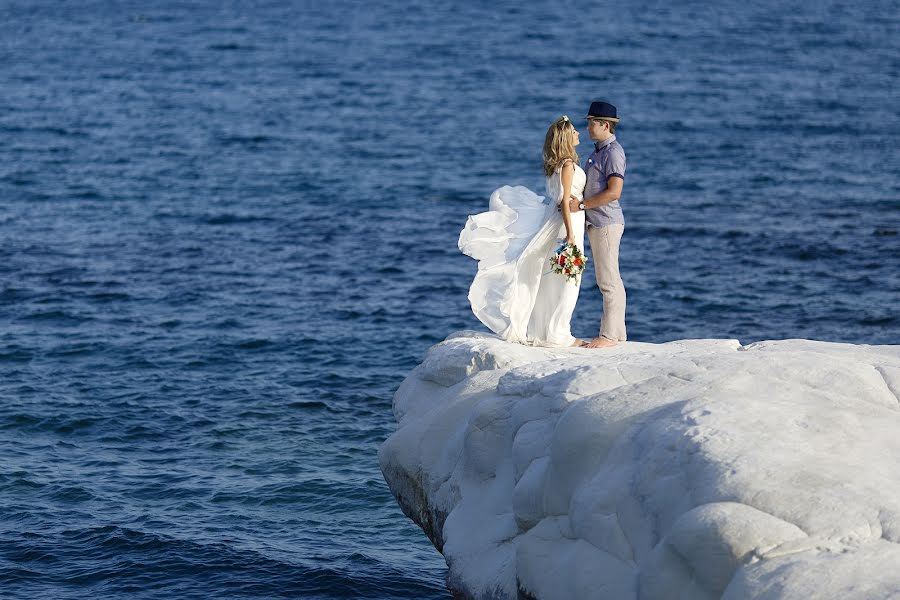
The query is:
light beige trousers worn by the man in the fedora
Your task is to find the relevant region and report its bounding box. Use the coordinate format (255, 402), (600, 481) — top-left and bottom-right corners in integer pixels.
(588, 224), (627, 342)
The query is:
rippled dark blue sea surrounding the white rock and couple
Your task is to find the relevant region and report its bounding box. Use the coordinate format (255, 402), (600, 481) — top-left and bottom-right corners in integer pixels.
(0, 0), (900, 598)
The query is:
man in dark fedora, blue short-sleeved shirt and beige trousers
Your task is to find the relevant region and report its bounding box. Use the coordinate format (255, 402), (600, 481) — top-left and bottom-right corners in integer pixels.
(569, 102), (626, 348)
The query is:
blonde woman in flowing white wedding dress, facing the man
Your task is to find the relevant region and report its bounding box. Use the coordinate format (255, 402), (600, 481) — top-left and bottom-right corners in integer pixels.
(459, 116), (586, 346)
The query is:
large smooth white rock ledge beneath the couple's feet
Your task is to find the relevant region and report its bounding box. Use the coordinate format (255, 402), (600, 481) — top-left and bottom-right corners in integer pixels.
(379, 332), (900, 600)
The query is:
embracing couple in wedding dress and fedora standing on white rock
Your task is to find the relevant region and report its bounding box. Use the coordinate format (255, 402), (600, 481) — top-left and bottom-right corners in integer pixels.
(459, 102), (626, 348)
